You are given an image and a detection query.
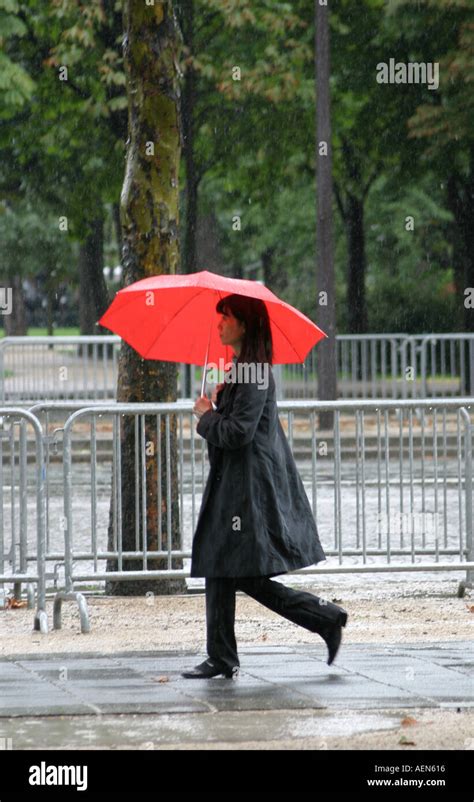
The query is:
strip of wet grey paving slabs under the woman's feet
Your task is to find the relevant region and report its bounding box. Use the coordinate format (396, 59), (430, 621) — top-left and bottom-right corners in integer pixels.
(0, 641), (474, 717)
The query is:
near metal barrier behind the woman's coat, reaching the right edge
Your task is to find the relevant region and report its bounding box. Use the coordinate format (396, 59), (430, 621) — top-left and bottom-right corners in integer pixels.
(49, 398), (474, 631)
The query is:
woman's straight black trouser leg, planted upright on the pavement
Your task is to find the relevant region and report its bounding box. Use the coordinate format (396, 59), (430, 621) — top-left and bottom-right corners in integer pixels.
(206, 577), (240, 669)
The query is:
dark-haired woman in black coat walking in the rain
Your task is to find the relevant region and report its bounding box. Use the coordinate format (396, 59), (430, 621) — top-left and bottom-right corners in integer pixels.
(182, 295), (347, 679)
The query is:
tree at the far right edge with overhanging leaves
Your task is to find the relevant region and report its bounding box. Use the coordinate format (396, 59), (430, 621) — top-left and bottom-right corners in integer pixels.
(397, 0), (474, 331)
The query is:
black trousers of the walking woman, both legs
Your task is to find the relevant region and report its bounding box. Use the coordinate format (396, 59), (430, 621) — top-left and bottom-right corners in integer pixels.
(206, 576), (346, 668)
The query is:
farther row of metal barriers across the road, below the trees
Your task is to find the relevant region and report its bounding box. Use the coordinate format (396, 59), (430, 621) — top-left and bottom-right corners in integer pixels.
(0, 333), (474, 404)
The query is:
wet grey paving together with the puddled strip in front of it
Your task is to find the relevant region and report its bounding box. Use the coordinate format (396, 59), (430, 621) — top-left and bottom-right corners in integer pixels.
(0, 641), (474, 749)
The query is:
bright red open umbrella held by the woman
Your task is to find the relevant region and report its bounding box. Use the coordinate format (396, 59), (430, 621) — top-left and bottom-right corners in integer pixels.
(98, 270), (327, 395)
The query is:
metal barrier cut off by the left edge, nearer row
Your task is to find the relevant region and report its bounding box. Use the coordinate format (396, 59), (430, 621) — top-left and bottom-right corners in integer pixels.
(0, 407), (48, 633)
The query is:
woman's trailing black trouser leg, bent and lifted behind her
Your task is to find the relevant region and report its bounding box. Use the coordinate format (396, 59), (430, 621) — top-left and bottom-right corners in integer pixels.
(235, 577), (347, 635)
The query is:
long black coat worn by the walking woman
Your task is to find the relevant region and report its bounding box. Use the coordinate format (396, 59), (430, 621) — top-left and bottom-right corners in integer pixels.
(191, 357), (326, 577)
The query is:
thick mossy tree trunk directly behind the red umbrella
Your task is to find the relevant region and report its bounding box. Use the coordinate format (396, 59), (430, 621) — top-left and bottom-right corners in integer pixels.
(106, 0), (186, 595)
